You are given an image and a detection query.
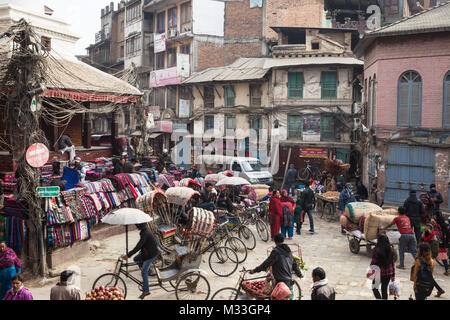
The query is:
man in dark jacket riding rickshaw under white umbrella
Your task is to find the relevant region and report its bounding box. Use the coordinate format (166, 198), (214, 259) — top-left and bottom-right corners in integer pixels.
(122, 223), (159, 299)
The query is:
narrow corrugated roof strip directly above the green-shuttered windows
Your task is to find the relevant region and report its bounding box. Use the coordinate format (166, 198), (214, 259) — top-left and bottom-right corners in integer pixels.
(264, 57), (364, 69)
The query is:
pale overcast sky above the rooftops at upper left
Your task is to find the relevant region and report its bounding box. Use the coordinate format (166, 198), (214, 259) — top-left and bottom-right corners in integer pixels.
(5, 0), (109, 55)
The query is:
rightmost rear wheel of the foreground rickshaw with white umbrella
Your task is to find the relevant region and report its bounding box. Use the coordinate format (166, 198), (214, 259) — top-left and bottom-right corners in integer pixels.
(175, 271), (211, 300)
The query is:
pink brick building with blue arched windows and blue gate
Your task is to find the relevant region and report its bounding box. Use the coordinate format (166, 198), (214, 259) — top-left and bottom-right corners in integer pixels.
(356, 3), (450, 208)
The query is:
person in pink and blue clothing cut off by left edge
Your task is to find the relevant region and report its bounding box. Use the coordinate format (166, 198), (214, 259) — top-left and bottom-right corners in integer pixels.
(0, 241), (22, 300)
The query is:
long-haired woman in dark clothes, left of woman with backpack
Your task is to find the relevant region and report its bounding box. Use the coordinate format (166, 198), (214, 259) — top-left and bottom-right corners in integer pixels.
(370, 234), (395, 300)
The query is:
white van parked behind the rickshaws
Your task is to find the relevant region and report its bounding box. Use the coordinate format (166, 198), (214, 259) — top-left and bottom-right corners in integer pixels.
(197, 155), (273, 186)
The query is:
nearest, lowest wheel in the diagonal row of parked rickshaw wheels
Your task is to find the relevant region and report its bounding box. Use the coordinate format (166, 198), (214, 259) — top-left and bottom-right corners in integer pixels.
(208, 247), (239, 277)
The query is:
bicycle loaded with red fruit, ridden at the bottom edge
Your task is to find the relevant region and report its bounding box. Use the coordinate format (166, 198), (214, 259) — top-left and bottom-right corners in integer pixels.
(211, 268), (302, 300)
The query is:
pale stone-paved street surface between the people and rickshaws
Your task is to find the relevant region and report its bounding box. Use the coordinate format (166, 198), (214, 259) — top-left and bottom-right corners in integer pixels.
(27, 211), (450, 300)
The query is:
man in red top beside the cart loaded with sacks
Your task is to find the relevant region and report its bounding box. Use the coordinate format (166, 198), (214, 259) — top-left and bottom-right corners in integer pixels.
(380, 207), (417, 270)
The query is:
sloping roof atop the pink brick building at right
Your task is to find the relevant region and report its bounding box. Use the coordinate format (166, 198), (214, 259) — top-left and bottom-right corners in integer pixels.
(365, 2), (450, 38)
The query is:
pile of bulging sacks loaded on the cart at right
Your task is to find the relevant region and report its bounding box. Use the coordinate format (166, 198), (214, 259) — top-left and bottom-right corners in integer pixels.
(340, 202), (399, 241)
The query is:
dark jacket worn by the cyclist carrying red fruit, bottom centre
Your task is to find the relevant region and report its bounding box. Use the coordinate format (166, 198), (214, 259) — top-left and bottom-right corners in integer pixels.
(255, 244), (302, 286)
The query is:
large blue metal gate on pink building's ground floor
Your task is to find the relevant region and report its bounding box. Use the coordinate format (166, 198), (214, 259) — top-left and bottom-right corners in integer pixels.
(385, 144), (435, 203)
